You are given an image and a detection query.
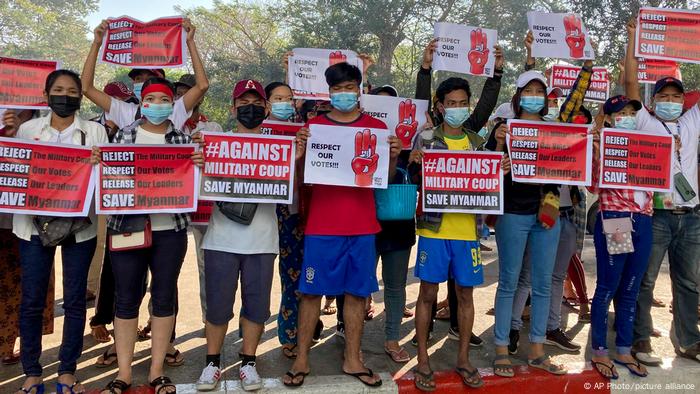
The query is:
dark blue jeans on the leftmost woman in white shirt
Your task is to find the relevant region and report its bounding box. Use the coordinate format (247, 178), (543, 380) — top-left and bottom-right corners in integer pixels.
(19, 235), (97, 376)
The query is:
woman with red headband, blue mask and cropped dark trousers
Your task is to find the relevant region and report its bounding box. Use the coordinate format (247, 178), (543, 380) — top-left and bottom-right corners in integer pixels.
(100, 78), (203, 394)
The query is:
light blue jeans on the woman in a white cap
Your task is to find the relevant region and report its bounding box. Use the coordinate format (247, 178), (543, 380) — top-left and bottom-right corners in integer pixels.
(494, 213), (561, 346)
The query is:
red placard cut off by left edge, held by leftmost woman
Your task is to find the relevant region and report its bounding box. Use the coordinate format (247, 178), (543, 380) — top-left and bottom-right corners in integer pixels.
(0, 137), (95, 216)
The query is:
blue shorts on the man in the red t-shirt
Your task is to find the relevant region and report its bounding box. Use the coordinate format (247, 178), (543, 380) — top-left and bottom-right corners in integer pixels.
(299, 234), (379, 297)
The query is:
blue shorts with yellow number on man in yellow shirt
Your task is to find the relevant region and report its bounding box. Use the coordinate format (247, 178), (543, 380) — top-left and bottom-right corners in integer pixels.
(414, 237), (484, 287)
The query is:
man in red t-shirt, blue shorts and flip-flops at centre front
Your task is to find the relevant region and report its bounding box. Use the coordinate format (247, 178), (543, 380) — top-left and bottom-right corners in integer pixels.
(284, 62), (401, 387)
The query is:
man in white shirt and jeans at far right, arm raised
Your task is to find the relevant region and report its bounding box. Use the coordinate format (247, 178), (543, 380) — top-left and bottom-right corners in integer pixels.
(625, 20), (700, 365)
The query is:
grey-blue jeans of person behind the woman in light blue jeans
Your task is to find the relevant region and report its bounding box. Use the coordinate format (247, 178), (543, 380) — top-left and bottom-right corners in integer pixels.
(510, 218), (576, 331)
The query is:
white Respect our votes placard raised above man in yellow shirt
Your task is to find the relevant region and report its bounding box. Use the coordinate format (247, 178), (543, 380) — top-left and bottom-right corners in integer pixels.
(433, 22), (498, 77)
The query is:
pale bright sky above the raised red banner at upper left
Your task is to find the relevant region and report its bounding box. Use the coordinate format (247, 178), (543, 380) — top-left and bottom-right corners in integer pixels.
(88, 0), (213, 27)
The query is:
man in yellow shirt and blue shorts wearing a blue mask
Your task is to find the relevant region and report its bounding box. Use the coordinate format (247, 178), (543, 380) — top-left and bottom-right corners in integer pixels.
(410, 41), (510, 391)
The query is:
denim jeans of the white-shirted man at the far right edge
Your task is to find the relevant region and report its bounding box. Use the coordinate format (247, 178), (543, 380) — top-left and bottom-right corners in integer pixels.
(634, 210), (700, 348)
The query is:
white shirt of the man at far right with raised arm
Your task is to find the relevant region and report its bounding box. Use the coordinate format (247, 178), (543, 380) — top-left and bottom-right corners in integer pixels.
(635, 105), (700, 207)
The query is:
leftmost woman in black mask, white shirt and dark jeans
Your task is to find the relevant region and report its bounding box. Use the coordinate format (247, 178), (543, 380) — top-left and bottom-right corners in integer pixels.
(12, 70), (107, 393)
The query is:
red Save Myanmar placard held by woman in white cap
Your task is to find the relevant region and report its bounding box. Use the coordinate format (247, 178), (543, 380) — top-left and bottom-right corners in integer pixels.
(506, 119), (593, 186)
